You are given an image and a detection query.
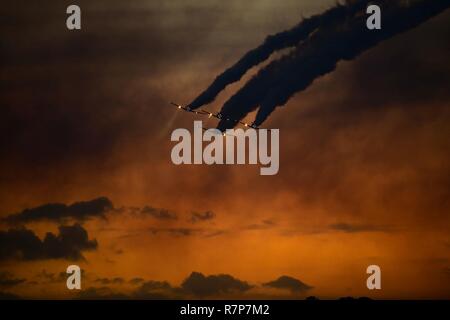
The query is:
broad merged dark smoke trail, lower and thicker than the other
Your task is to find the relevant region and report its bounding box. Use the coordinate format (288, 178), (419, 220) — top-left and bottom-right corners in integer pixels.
(214, 0), (450, 130)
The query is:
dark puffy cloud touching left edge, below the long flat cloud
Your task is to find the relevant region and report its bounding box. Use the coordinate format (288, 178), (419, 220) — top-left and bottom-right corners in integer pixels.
(0, 224), (97, 261)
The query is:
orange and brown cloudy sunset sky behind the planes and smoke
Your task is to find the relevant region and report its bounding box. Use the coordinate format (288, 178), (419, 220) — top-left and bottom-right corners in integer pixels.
(0, 0), (450, 299)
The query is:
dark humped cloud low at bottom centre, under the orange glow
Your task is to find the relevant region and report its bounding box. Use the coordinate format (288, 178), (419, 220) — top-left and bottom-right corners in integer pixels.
(181, 272), (252, 297)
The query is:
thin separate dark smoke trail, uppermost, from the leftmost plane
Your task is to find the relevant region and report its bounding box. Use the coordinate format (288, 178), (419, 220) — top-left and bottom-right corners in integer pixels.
(188, 0), (370, 109)
